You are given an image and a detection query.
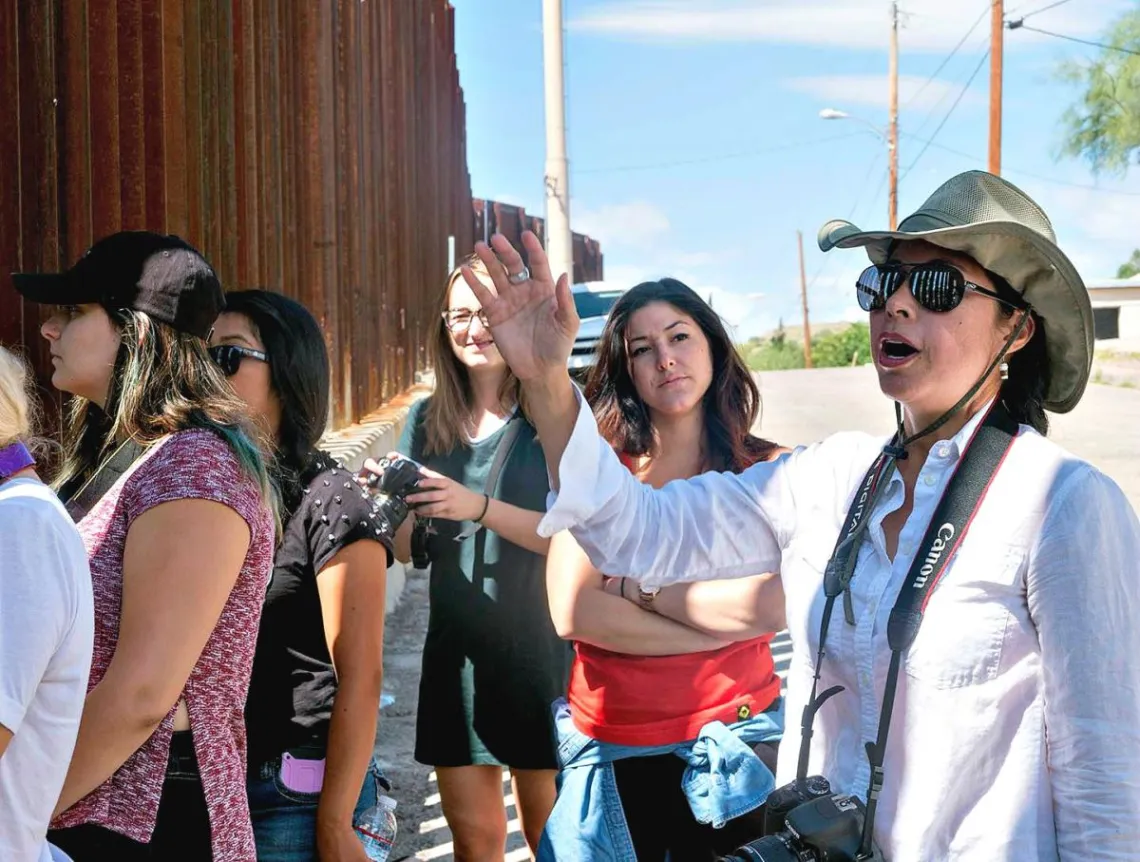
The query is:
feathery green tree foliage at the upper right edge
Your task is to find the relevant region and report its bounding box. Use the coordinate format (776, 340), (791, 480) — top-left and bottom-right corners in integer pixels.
(1060, 8), (1140, 174)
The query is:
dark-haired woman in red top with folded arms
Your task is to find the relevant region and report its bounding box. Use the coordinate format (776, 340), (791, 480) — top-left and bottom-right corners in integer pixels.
(540, 278), (784, 862)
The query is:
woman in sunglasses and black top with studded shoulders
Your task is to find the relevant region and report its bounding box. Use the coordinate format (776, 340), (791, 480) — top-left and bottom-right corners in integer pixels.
(210, 291), (390, 862)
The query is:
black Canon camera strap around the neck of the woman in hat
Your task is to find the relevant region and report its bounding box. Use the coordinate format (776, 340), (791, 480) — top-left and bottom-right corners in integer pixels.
(798, 402), (1018, 859)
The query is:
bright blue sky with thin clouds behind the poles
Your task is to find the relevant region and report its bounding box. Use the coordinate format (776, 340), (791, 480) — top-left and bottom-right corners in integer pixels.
(453, 0), (1140, 339)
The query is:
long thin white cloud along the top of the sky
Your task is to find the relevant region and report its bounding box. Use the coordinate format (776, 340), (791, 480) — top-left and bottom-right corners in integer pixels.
(569, 0), (1131, 51)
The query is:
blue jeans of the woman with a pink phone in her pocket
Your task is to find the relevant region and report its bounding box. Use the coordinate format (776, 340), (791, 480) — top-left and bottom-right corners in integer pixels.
(246, 757), (390, 862)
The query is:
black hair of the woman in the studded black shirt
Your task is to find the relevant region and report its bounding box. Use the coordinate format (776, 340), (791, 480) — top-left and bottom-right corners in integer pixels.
(225, 290), (329, 513)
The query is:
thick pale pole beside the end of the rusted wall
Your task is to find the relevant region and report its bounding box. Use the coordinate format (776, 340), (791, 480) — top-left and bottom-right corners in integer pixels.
(543, 0), (573, 282)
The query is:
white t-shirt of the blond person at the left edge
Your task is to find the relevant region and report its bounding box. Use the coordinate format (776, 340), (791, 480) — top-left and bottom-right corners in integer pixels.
(0, 479), (95, 862)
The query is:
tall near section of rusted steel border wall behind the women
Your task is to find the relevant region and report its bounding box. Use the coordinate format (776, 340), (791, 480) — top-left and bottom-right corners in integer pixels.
(0, 0), (474, 426)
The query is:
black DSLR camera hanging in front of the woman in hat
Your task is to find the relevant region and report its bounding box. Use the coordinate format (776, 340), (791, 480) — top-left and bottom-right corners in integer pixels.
(722, 775), (881, 862)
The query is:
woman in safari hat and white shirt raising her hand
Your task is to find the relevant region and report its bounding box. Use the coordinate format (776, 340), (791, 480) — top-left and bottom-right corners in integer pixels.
(451, 171), (1140, 861)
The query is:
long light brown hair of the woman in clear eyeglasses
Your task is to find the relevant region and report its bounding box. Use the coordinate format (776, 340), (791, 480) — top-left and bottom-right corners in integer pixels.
(424, 254), (526, 455)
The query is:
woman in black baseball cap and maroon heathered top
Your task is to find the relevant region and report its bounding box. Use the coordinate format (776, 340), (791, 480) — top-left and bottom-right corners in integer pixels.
(14, 231), (274, 862)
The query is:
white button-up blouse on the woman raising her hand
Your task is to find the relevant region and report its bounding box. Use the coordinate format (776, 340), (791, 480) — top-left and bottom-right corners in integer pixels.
(539, 394), (1140, 862)
